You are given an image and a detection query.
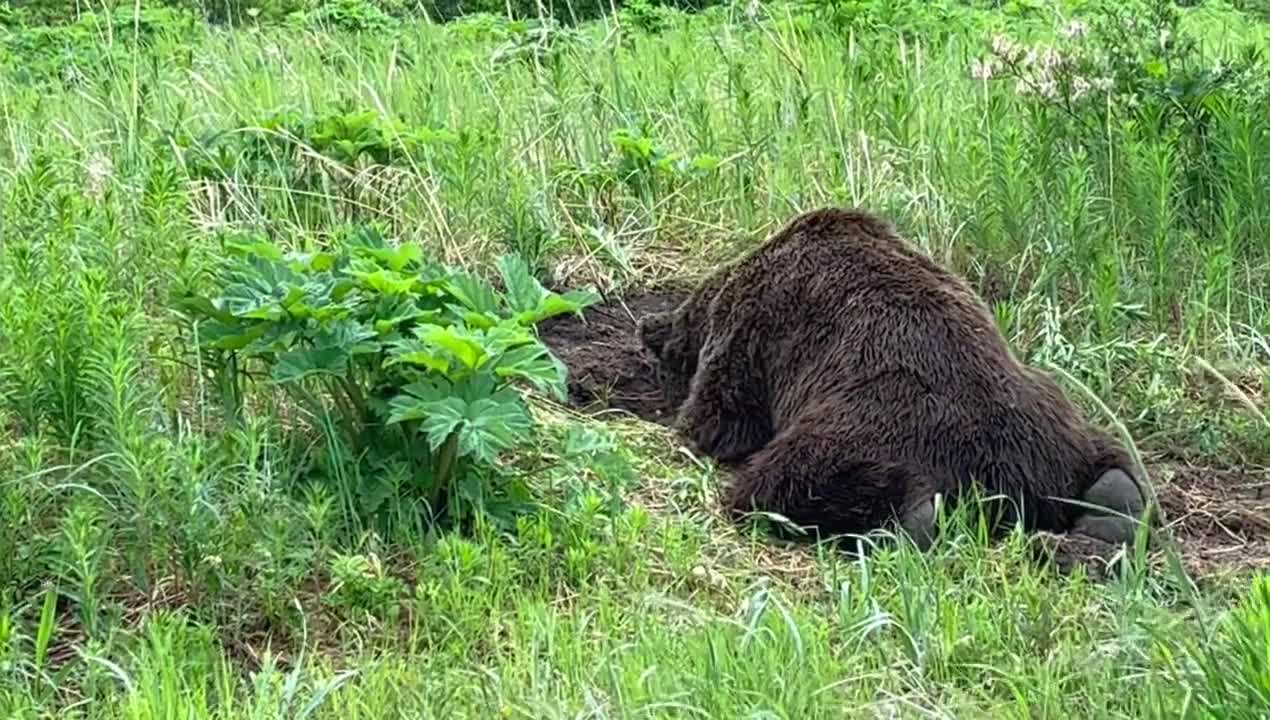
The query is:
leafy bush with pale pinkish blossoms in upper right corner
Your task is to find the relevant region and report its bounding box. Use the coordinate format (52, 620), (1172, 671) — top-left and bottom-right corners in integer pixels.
(972, 0), (1270, 229)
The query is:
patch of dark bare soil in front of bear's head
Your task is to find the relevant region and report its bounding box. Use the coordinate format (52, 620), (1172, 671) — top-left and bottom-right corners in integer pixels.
(540, 290), (687, 424)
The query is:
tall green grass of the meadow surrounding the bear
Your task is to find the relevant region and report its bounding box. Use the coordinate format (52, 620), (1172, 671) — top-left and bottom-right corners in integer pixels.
(0, 4), (1270, 719)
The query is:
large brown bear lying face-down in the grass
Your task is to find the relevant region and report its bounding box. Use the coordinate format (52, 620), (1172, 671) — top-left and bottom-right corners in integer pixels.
(639, 208), (1146, 547)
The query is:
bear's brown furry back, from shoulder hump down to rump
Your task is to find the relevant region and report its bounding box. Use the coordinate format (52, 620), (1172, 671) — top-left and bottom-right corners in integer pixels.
(736, 208), (1112, 500)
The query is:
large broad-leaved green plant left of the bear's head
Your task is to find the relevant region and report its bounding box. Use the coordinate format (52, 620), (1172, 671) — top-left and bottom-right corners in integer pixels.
(177, 227), (597, 530)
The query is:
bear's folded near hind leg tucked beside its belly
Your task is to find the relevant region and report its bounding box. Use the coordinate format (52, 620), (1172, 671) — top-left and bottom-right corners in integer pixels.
(724, 432), (936, 549)
